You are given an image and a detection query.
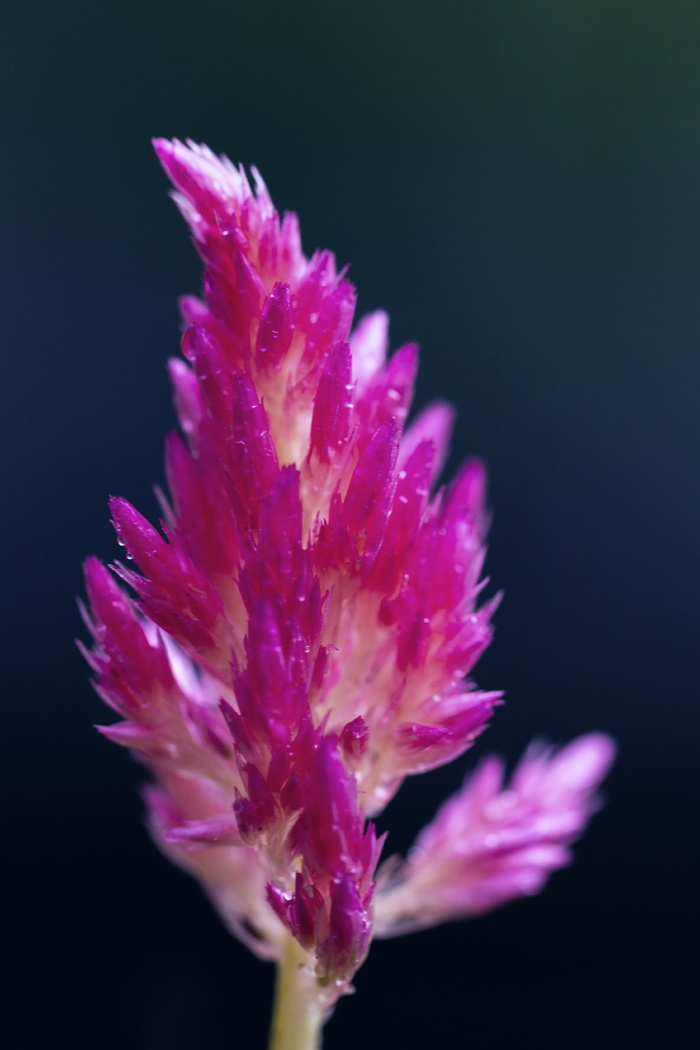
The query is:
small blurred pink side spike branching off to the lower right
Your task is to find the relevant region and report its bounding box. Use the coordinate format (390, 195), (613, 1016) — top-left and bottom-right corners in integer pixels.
(375, 734), (615, 937)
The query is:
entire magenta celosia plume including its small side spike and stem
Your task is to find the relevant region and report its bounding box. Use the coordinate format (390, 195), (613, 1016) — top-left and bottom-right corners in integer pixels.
(86, 141), (611, 1047)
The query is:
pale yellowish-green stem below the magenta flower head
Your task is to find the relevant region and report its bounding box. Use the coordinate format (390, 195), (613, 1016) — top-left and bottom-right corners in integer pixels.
(270, 936), (323, 1050)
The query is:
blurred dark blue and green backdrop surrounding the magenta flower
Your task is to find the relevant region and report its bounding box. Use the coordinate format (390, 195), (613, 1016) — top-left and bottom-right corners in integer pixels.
(0, 0), (700, 1050)
